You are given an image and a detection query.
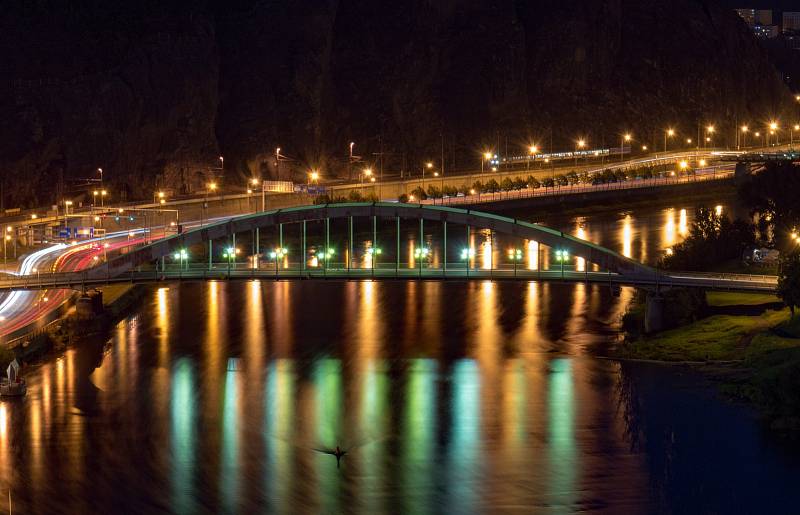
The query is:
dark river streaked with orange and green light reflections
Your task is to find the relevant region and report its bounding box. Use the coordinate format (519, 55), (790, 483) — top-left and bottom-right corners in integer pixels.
(0, 197), (800, 514)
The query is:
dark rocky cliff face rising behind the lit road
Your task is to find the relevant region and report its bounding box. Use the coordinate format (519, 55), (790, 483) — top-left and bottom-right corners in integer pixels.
(0, 0), (792, 206)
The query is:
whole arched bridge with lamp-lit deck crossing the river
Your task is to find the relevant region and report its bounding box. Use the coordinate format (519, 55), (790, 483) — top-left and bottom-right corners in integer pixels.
(0, 202), (776, 292)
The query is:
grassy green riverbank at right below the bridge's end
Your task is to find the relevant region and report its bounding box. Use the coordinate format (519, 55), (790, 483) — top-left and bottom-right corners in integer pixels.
(612, 292), (800, 431)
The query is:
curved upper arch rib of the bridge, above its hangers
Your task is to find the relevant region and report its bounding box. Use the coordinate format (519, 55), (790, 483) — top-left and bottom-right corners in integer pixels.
(90, 202), (656, 279)
